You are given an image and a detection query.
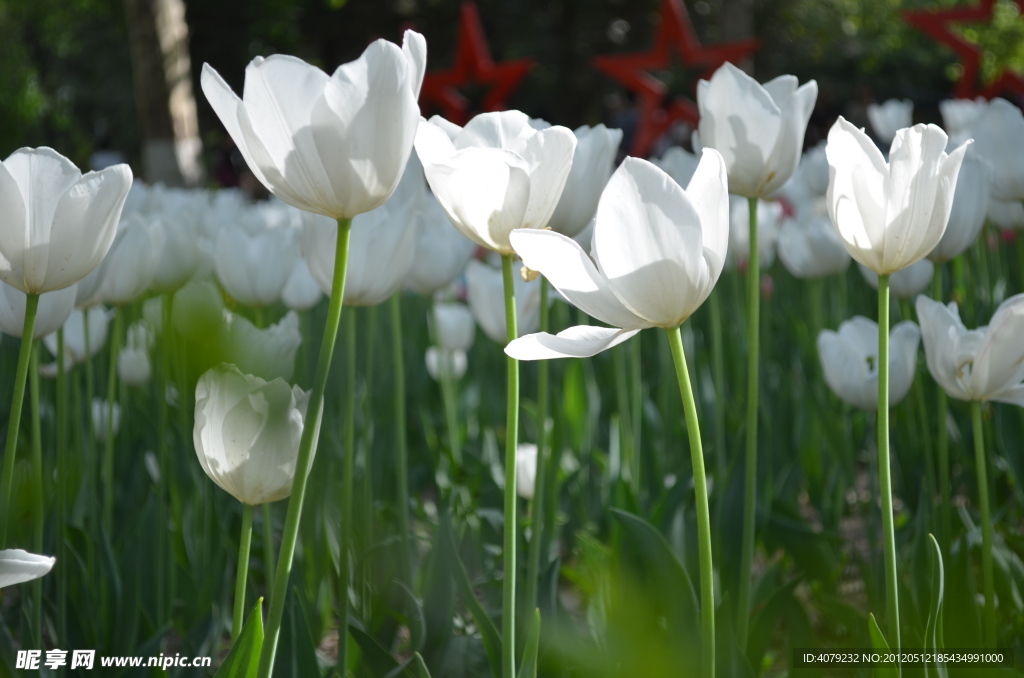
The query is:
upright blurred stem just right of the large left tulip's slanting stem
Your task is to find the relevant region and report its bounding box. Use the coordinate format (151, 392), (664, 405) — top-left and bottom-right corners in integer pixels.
(338, 310), (358, 676)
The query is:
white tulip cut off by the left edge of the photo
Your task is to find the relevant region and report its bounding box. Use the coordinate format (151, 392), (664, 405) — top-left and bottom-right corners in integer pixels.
(0, 147), (131, 294)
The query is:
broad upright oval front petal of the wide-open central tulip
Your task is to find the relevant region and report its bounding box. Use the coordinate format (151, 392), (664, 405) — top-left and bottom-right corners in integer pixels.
(594, 158), (713, 328)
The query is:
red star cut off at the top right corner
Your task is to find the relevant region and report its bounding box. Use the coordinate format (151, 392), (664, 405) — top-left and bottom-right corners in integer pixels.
(903, 0), (1024, 98)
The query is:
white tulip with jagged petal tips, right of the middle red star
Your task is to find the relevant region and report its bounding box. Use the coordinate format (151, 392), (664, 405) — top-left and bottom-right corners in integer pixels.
(697, 62), (818, 198)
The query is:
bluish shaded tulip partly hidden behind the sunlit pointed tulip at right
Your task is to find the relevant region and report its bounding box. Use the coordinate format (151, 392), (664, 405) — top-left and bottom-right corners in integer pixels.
(928, 149), (992, 263)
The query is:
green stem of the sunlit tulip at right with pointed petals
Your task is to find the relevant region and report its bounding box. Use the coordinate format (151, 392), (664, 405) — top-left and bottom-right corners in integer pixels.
(878, 274), (900, 650)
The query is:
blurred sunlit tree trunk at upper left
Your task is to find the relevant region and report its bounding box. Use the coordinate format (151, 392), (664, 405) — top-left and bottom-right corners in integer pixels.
(125, 0), (203, 186)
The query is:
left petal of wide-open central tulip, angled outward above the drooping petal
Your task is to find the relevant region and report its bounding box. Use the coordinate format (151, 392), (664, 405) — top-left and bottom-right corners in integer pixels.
(509, 228), (651, 328)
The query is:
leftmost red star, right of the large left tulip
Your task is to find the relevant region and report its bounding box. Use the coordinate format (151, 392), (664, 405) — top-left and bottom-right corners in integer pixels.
(420, 2), (534, 125)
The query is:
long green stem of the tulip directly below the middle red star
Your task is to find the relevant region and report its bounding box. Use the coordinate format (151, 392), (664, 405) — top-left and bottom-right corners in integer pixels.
(736, 198), (761, 648)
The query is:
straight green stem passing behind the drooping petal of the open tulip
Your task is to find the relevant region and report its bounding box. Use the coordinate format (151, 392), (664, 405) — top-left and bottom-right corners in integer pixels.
(502, 254), (519, 678)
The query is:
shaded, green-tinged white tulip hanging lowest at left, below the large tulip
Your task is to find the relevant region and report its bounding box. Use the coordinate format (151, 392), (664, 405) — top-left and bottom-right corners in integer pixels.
(193, 365), (312, 505)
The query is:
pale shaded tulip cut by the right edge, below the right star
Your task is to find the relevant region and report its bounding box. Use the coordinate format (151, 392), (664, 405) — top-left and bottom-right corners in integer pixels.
(971, 98), (1024, 201)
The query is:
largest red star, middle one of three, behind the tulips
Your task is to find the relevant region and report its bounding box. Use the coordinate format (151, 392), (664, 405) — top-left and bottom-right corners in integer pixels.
(594, 0), (761, 157)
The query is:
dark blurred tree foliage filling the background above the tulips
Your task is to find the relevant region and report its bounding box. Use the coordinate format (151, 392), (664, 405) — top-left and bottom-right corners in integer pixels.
(0, 0), (1024, 178)
